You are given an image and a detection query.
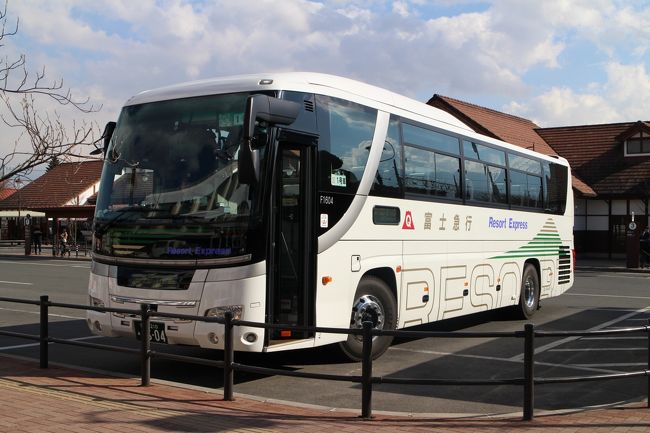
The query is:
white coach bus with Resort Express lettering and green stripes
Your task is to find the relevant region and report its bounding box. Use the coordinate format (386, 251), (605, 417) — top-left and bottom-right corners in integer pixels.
(88, 73), (573, 359)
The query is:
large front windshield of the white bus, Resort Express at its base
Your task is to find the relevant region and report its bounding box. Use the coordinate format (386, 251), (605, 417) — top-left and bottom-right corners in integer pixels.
(94, 93), (264, 261)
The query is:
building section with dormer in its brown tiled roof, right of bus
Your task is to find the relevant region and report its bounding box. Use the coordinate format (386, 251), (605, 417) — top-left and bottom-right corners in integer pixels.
(537, 121), (650, 255)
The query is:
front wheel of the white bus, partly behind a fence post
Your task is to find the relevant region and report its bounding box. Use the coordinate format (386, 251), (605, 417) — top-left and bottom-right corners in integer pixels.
(340, 276), (397, 361)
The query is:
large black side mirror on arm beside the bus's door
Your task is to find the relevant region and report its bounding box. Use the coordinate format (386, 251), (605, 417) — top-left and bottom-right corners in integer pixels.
(237, 94), (301, 185)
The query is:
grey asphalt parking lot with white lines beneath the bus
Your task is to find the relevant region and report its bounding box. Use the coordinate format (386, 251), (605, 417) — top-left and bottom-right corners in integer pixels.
(0, 257), (650, 414)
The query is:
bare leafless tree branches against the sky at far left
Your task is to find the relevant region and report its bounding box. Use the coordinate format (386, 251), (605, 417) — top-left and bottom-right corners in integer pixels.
(0, 0), (101, 182)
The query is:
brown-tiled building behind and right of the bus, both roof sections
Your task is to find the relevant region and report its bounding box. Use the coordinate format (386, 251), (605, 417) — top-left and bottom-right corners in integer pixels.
(428, 95), (650, 257)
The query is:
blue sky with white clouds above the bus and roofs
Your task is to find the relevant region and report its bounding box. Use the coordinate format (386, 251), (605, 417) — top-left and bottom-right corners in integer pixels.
(0, 0), (650, 172)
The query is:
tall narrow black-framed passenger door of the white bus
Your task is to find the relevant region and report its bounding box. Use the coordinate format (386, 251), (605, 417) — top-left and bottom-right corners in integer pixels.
(269, 134), (316, 345)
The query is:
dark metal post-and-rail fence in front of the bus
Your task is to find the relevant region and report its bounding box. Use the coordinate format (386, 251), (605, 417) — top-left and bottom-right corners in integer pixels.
(0, 296), (650, 421)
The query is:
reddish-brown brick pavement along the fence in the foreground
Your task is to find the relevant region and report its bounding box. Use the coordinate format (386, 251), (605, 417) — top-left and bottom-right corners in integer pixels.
(0, 248), (650, 433)
